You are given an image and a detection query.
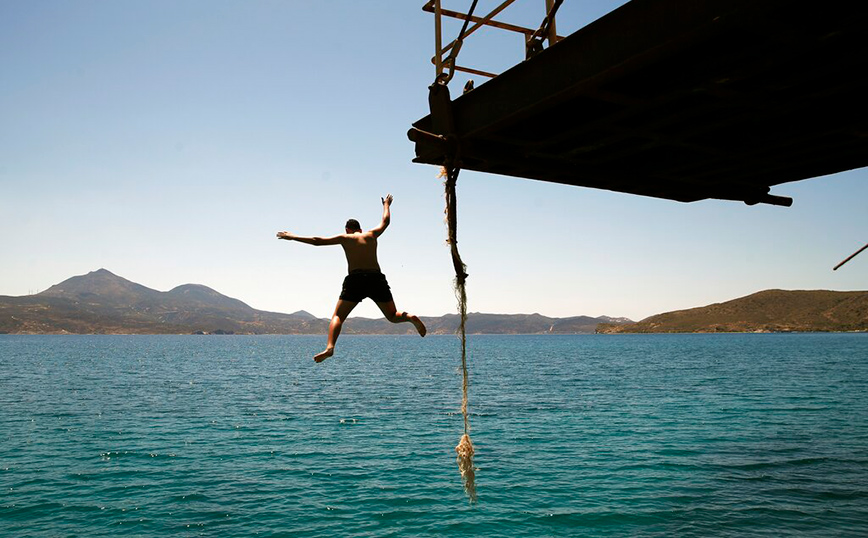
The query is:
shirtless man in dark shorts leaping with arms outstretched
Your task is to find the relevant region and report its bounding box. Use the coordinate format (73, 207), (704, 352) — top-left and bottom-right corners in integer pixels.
(277, 194), (427, 362)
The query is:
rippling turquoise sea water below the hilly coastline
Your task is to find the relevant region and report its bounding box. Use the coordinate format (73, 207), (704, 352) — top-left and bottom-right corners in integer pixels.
(0, 334), (868, 537)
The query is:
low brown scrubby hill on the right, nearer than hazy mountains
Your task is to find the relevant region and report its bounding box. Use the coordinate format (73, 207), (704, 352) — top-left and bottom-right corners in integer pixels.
(598, 290), (868, 333)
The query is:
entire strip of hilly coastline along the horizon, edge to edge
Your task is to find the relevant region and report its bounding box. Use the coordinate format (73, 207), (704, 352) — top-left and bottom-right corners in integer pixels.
(0, 269), (868, 335)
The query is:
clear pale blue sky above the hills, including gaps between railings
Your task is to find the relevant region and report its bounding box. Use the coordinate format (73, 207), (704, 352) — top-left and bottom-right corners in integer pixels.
(0, 0), (868, 319)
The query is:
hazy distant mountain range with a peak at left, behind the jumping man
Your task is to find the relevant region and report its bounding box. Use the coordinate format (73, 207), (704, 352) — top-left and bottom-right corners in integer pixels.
(0, 269), (630, 334)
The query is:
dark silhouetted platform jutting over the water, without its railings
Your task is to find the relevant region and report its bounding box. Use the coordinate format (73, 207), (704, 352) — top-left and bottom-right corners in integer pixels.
(409, 0), (868, 205)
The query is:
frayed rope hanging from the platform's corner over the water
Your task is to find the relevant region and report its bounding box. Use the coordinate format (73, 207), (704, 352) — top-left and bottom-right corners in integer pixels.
(443, 162), (476, 502)
